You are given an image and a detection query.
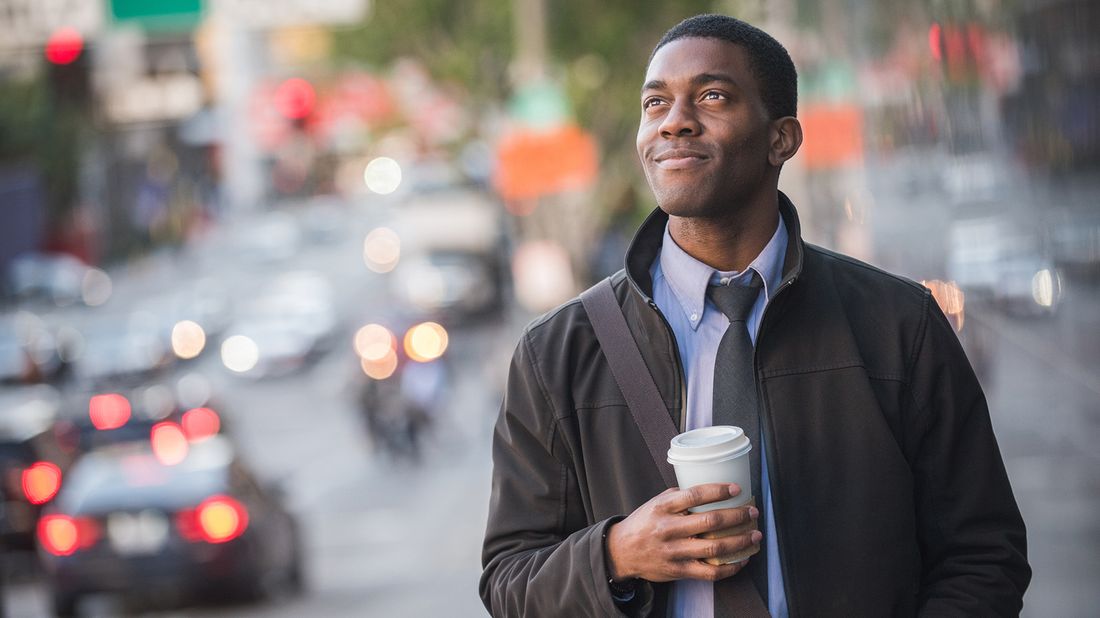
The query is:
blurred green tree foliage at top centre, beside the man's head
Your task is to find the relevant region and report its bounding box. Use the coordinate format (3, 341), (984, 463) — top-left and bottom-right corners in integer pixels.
(334, 0), (715, 215)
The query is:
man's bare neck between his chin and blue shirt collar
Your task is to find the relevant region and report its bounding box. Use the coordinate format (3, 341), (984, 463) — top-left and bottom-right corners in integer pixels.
(669, 195), (779, 272)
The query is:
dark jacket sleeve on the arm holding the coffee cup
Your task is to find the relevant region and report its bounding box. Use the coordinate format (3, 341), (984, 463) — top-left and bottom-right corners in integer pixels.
(480, 338), (651, 617)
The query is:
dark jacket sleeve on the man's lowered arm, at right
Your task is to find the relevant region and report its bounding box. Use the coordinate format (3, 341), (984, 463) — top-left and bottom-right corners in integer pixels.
(908, 301), (1031, 616)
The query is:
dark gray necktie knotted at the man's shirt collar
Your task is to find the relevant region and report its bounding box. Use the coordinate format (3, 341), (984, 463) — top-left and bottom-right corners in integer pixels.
(707, 271), (768, 602)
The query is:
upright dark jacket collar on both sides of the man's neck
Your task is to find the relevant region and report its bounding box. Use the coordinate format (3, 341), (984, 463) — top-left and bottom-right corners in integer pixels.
(626, 191), (802, 302)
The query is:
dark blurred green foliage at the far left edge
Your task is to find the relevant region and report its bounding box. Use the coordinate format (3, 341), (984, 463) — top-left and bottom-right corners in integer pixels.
(0, 74), (87, 227)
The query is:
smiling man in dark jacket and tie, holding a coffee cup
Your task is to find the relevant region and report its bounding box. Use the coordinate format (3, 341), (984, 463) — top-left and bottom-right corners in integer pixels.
(481, 15), (1031, 618)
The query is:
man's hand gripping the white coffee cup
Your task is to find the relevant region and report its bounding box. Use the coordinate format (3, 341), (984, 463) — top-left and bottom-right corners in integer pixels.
(607, 483), (762, 582)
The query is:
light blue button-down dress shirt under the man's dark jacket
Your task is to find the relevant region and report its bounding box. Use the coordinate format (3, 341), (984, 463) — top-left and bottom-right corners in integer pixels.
(650, 218), (788, 618)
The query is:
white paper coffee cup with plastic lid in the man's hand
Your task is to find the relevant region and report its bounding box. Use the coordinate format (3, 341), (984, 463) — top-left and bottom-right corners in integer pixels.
(669, 424), (752, 512)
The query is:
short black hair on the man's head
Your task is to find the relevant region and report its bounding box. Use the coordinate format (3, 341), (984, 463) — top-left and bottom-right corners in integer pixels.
(649, 14), (799, 120)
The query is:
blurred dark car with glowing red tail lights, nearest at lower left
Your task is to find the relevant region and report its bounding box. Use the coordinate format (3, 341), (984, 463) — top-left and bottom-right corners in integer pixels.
(37, 437), (303, 616)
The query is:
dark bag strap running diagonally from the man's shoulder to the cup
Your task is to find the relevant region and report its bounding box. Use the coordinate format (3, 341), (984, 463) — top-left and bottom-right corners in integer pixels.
(581, 279), (678, 487)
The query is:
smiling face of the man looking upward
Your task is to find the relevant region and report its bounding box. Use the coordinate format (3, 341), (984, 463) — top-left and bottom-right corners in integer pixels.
(638, 37), (777, 217)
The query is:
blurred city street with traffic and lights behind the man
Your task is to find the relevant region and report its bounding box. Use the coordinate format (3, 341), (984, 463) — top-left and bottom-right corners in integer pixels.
(0, 0), (1100, 618)
